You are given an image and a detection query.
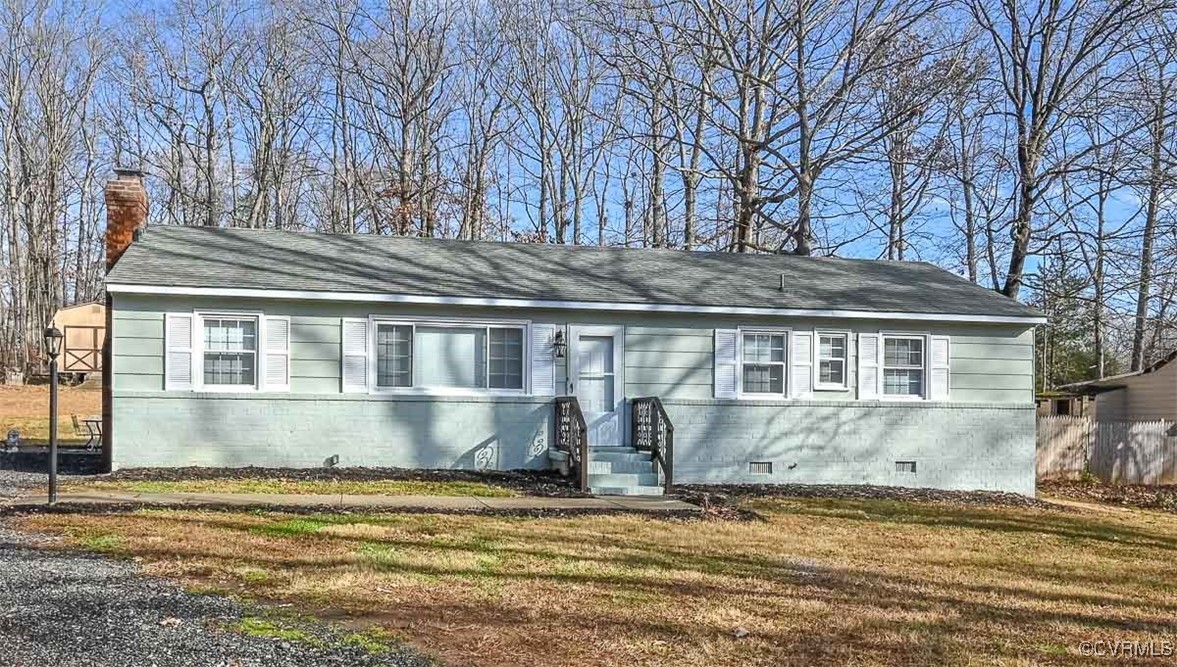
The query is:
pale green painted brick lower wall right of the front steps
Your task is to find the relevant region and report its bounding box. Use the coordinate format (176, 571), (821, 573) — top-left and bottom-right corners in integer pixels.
(663, 400), (1035, 495)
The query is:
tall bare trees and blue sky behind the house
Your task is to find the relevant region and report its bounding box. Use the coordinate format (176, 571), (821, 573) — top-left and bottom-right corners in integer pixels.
(0, 0), (1177, 383)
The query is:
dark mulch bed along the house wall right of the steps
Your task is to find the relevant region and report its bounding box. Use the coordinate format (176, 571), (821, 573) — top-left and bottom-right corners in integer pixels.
(674, 483), (1058, 512)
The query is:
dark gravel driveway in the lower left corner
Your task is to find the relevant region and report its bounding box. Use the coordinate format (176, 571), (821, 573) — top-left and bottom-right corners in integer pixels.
(0, 522), (427, 667)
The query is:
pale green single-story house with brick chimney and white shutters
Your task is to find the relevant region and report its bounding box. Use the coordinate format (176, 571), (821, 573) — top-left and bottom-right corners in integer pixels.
(106, 172), (1044, 494)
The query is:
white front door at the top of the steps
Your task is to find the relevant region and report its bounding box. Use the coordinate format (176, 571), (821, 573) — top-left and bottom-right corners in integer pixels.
(568, 326), (625, 447)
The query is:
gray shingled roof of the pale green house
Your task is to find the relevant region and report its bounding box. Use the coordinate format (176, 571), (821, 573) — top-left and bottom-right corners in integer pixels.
(107, 226), (1039, 318)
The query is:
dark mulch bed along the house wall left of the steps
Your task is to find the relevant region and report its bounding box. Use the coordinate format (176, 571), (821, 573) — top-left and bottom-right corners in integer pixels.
(99, 467), (585, 498)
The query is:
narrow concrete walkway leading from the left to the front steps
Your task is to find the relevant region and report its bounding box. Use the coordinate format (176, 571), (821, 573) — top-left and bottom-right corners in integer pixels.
(0, 491), (699, 512)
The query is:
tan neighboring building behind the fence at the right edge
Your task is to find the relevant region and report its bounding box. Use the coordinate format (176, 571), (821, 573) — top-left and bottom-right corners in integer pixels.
(1064, 351), (1177, 421)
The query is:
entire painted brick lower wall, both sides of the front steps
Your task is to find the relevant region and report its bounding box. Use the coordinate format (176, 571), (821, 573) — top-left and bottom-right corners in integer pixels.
(114, 392), (1035, 494)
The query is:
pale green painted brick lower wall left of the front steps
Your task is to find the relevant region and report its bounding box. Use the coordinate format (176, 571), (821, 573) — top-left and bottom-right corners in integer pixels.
(114, 392), (552, 469)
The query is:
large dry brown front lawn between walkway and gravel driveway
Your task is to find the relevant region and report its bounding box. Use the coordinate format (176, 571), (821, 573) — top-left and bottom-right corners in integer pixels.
(21, 499), (1177, 667)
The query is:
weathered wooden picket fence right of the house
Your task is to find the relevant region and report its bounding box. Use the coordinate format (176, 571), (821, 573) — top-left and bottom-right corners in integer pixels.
(1038, 416), (1177, 485)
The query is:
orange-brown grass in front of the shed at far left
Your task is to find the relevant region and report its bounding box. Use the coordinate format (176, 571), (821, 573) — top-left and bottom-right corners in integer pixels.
(0, 385), (102, 442)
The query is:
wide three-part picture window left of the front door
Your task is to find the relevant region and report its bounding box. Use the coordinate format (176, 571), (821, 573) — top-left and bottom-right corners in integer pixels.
(375, 322), (526, 392)
